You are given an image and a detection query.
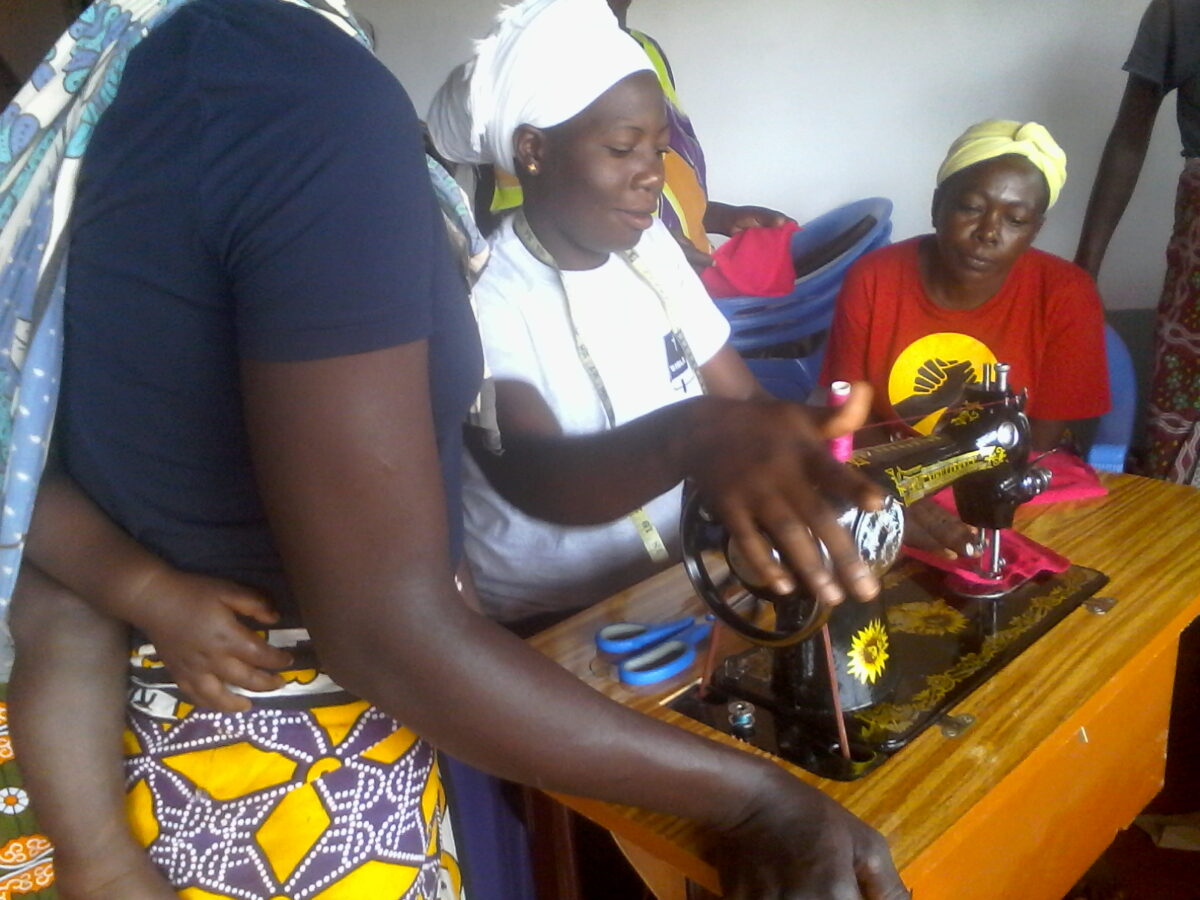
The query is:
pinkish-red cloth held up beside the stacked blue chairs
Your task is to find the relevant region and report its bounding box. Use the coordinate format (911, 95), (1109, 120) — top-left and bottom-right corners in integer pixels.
(700, 222), (800, 298)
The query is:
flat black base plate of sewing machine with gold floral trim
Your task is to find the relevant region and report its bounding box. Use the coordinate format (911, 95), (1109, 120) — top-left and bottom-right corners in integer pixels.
(668, 560), (1108, 781)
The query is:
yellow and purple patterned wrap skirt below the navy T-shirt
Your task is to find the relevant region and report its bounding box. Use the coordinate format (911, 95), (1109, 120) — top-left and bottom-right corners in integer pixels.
(125, 638), (463, 900)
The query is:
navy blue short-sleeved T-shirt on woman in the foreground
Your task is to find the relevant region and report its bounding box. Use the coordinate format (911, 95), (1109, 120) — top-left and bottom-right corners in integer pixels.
(59, 0), (481, 611)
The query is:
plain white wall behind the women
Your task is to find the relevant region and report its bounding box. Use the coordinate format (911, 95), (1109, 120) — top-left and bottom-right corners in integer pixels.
(355, 0), (1180, 308)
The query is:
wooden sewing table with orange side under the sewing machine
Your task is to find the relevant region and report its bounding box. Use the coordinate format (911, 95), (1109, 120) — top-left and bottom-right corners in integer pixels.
(530, 475), (1200, 900)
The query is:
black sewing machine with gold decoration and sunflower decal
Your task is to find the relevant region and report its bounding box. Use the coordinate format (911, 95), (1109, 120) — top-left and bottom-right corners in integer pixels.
(671, 364), (1108, 780)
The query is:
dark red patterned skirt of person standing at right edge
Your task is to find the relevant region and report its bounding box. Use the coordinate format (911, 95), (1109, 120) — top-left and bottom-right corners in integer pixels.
(1139, 158), (1200, 484)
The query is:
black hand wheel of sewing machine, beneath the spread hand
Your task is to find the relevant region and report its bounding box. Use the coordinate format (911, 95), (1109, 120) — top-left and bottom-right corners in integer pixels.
(680, 493), (833, 647)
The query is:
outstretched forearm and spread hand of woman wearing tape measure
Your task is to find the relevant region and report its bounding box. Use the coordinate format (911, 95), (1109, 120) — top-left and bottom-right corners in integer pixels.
(468, 382), (878, 604)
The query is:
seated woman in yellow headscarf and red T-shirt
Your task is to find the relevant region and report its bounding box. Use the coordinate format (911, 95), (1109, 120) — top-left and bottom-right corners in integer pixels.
(823, 120), (1109, 449)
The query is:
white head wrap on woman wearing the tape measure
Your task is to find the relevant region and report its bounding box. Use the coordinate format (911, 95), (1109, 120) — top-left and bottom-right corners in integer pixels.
(428, 0), (650, 172)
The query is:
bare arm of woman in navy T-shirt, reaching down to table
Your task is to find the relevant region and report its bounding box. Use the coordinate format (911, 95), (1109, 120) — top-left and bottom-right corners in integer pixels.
(244, 342), (907, 900)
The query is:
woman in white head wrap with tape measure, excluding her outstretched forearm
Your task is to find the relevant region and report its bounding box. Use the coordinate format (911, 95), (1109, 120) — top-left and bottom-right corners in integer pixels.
(453, 0), (782, 631)
